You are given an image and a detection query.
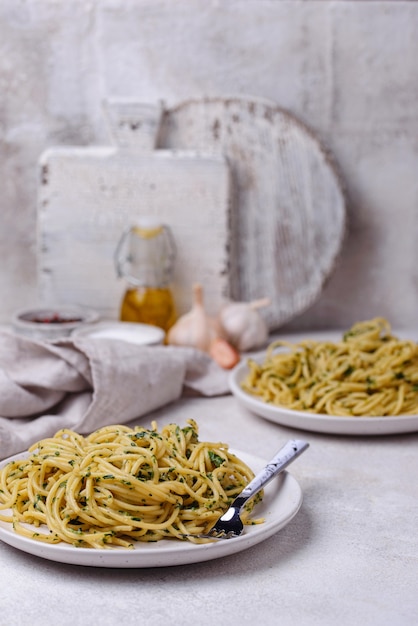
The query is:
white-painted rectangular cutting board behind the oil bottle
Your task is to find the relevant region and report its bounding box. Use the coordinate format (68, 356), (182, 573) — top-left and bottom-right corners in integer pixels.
(38, 147), (230, 319)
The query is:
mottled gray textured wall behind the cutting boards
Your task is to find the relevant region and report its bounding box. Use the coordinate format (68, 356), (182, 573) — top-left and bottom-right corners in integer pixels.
(0, 0), (418, 329)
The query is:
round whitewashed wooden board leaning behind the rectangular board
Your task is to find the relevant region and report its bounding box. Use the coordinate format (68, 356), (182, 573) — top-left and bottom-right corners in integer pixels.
(157, 97), (346, 330)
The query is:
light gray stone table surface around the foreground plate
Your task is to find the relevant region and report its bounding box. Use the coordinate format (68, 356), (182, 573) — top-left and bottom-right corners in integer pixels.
(0, 396), (418, 626)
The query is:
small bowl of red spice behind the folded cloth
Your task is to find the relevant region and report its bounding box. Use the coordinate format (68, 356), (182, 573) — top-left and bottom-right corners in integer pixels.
(12, 305), (99, 341)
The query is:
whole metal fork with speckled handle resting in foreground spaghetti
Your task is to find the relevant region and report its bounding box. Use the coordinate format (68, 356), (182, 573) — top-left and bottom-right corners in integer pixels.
(194, 439), (309, 539)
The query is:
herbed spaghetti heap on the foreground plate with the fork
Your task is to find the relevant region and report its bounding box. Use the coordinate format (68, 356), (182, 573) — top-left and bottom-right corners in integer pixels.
(0, 420), (261, 548)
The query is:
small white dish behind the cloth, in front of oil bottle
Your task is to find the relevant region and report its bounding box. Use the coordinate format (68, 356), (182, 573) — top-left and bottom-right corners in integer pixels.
(72, 322), (165, 346)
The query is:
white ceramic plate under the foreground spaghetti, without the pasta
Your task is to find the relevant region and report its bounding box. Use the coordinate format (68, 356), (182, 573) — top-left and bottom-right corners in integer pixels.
(0, 451), (302, 568)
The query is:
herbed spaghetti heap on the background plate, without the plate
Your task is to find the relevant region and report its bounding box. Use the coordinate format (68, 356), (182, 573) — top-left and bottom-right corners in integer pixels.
(242, 317), (418, 417)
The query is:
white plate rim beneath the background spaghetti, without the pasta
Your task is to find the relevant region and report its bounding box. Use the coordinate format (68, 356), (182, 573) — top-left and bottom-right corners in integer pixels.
(229, 356), (418, 435)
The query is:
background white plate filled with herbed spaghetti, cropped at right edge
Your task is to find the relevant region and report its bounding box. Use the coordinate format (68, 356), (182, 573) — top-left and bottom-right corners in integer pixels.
(229, 318), (418, 435)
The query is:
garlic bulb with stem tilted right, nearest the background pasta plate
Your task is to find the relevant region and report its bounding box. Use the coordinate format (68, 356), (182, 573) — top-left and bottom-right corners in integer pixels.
(218, 298), (270, 352)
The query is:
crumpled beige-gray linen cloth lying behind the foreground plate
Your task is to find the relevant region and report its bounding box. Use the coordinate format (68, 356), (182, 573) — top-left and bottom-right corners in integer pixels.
(0, 331), (228, 459)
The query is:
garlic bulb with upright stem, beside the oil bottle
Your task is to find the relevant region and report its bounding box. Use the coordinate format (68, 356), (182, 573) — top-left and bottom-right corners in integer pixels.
(167, 283), (216, 352)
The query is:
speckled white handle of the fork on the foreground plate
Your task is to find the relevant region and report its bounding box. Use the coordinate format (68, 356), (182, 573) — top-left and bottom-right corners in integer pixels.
(233, 439), (309, 508)
